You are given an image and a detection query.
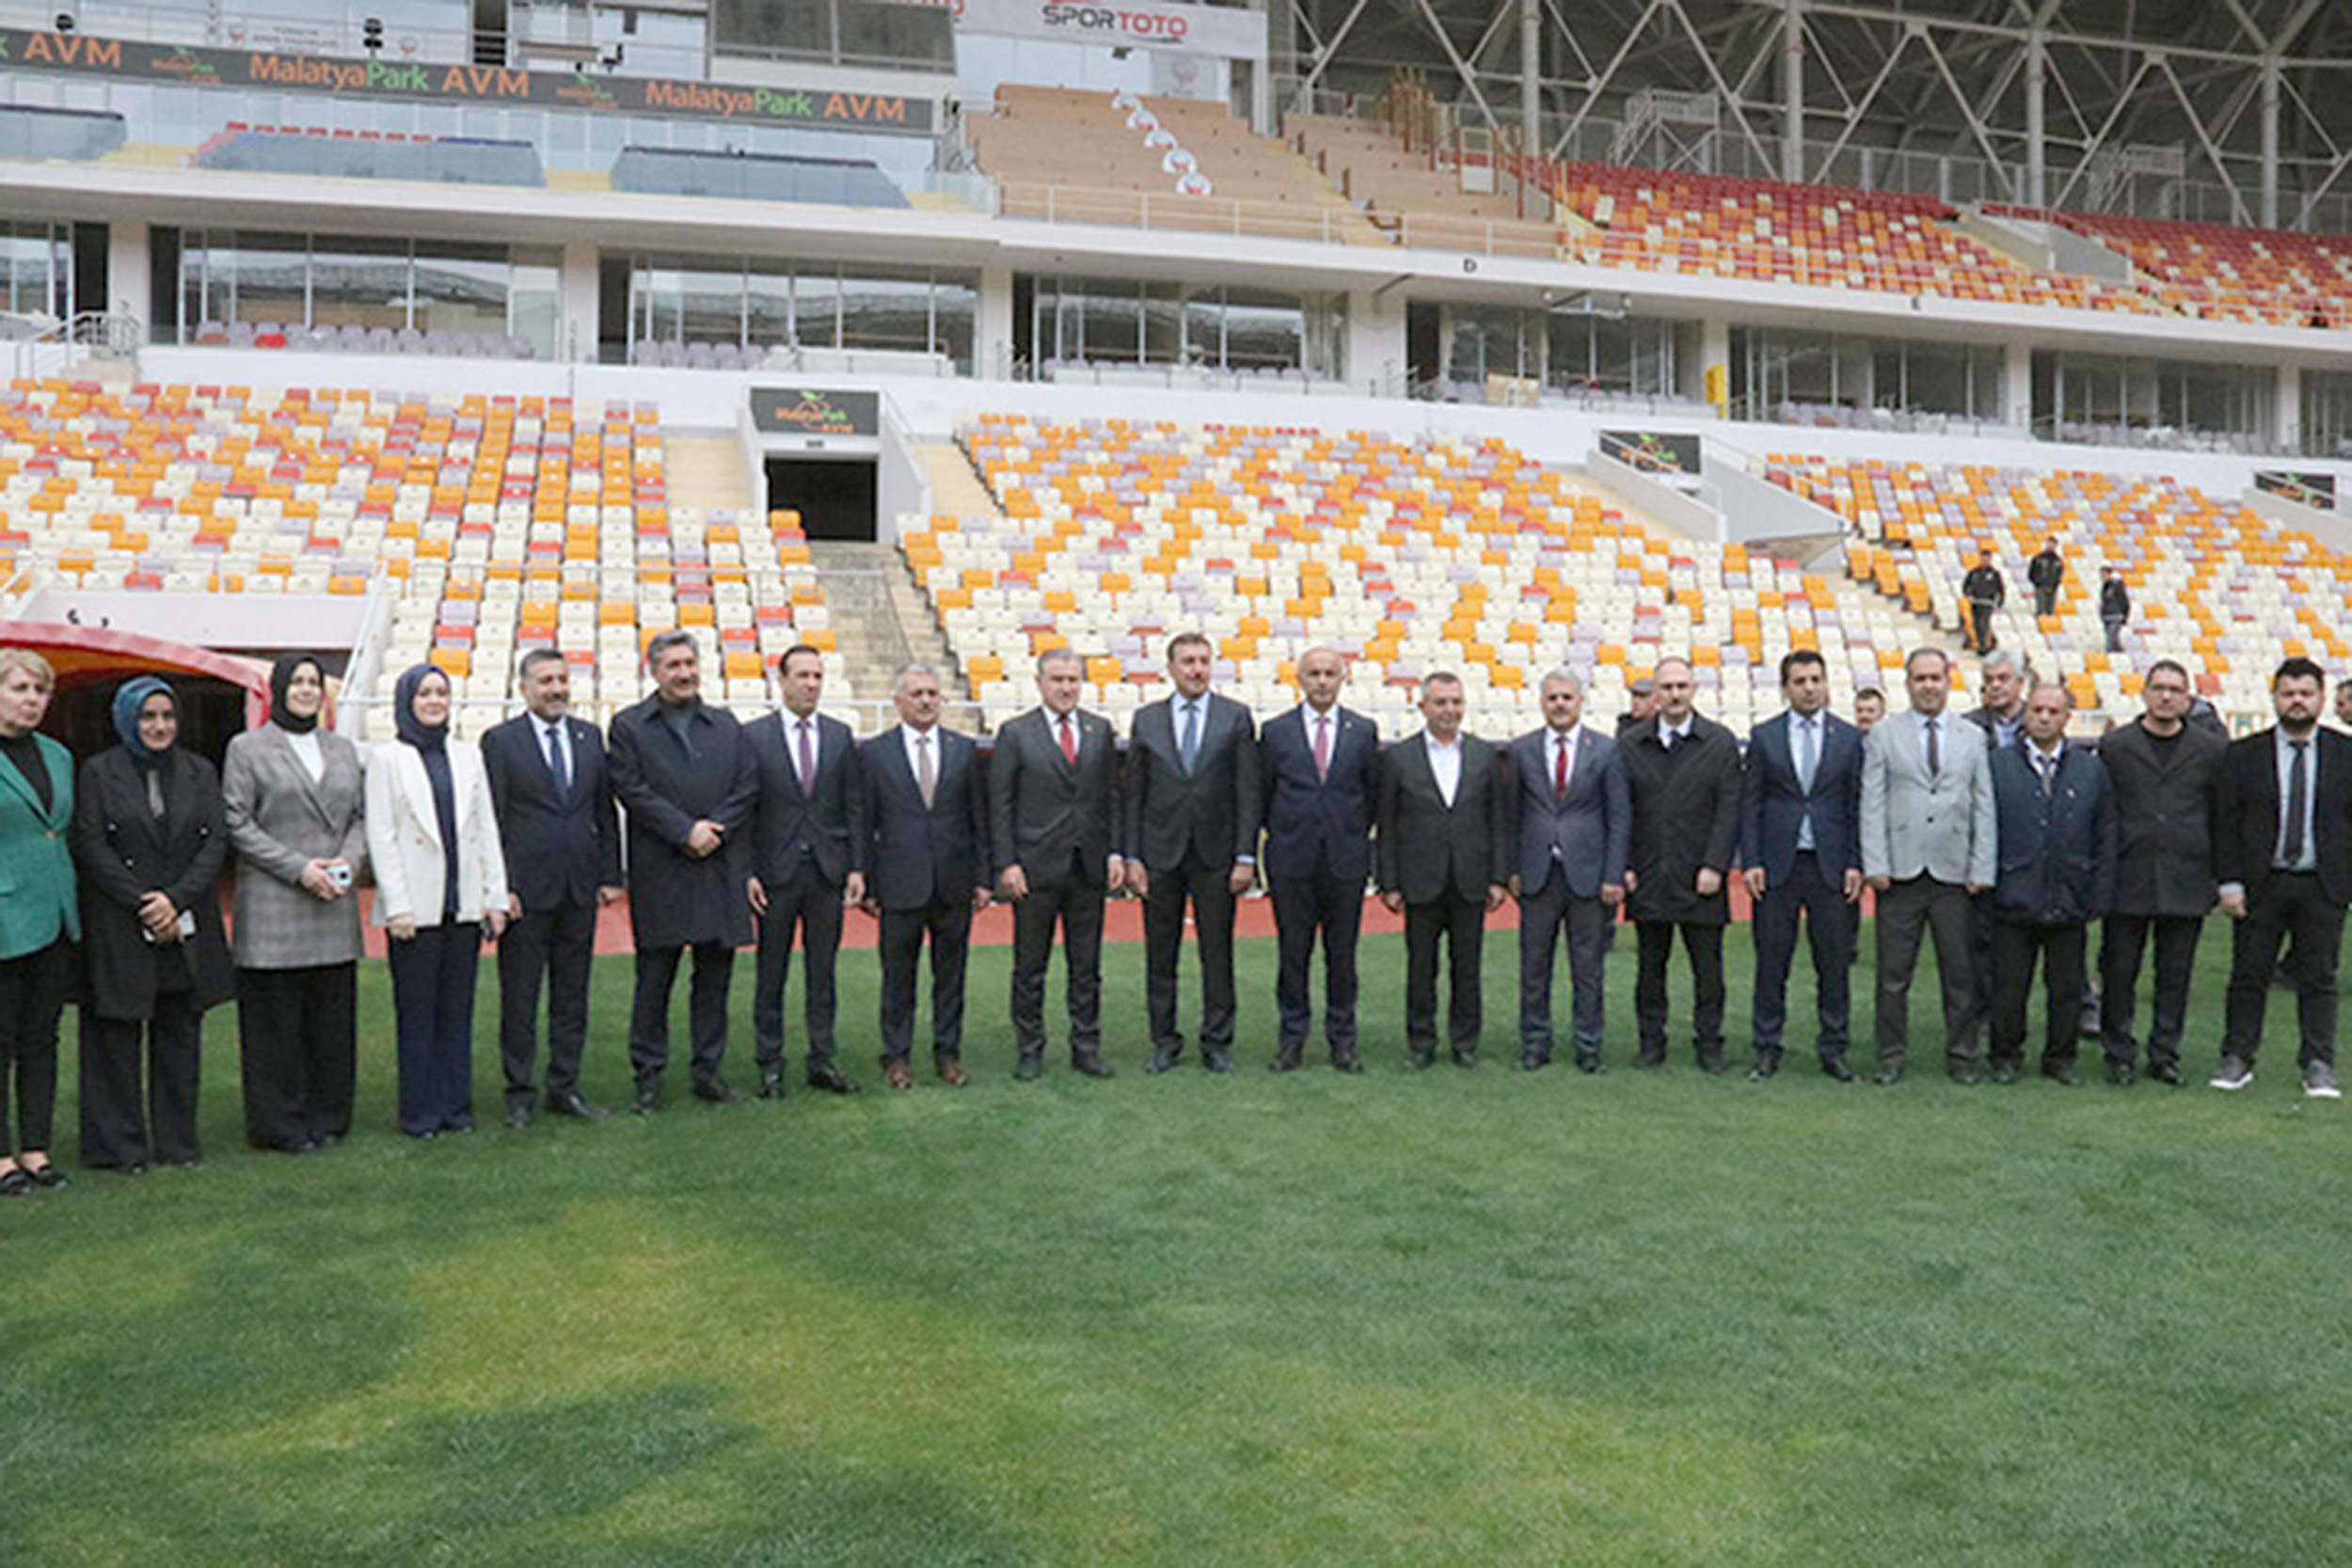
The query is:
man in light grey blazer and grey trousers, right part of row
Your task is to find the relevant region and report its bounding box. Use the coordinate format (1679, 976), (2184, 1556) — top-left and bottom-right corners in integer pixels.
(1863, 649), (1999, 1084)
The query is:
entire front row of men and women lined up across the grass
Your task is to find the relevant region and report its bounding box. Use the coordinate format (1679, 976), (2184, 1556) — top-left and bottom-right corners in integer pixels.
(0, 632), (2352, 1196)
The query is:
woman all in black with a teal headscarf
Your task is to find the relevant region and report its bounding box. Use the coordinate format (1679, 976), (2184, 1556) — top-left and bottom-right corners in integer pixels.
(73, 674), (235, 1176)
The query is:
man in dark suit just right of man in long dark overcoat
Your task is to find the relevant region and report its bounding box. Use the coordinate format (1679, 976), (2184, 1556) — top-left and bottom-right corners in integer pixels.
(743, 644), (866, 1101)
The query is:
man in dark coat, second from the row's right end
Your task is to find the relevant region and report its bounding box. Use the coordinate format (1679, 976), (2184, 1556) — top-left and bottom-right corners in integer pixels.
(2098, 658), (2230, 1086)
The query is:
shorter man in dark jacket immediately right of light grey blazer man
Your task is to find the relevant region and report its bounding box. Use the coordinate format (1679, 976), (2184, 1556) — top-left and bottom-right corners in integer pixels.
(1988, 682), (2115, 1088)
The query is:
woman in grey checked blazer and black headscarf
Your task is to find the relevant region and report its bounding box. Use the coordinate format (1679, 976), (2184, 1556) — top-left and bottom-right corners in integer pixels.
(221, 654), (367, 1154)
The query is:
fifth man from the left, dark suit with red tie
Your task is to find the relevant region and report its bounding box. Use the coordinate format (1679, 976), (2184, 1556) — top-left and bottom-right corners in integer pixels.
(988, 649), (1124, 1082)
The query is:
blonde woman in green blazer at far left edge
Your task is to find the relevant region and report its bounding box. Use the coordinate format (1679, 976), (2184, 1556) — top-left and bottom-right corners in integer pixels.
(0, 649), (83, 1199)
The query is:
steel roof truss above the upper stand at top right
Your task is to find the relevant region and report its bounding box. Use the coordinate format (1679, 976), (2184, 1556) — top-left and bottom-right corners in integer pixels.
(1268, 0), (2352, 228)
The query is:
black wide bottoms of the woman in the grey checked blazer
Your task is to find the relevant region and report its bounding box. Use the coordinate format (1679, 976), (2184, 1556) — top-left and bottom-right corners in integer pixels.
(238, 964), (360, 1149)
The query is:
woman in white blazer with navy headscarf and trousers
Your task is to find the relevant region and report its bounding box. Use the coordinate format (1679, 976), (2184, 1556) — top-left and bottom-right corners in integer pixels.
(367, 665), (506, 1138)
